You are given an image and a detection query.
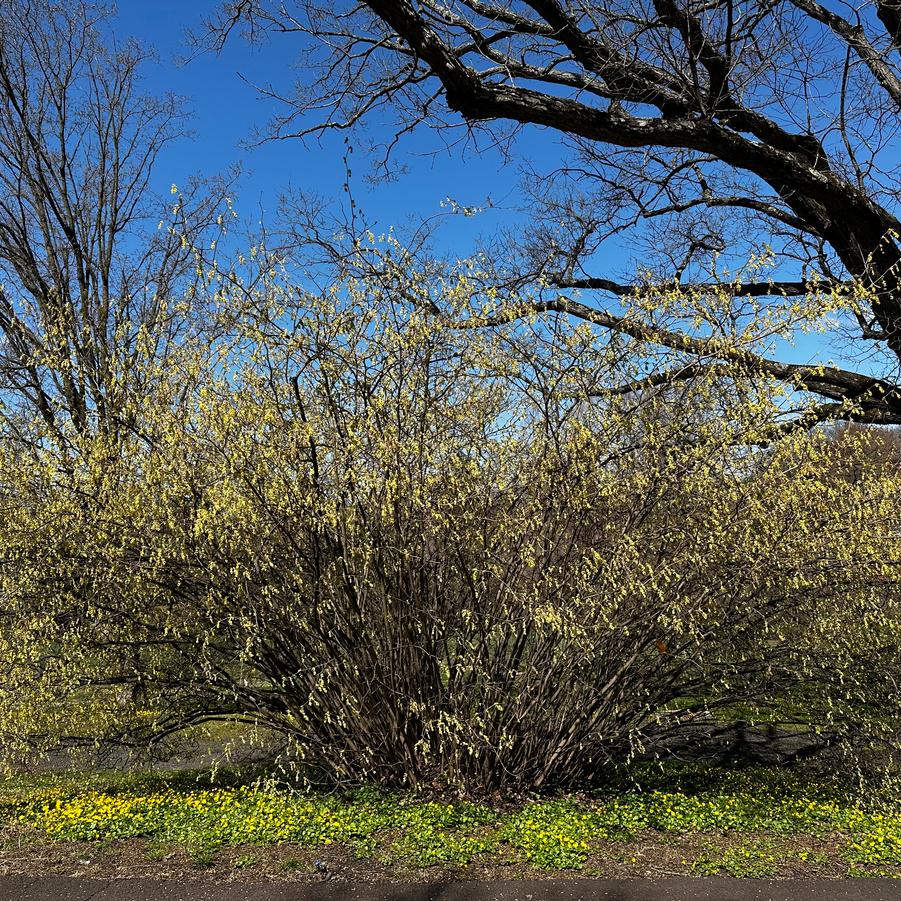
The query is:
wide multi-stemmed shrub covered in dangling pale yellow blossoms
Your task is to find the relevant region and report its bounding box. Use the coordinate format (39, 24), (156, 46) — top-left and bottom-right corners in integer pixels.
(0, 251), (901, 788)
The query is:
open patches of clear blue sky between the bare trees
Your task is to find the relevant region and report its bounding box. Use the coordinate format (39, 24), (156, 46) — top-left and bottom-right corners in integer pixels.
(112, 0), (842, 370)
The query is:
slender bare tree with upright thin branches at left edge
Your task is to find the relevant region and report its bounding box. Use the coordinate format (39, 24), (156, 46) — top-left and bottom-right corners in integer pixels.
(0, 2), (236, 434)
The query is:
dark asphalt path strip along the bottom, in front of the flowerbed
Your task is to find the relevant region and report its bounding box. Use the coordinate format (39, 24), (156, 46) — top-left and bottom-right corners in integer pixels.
(0, 876), (901, 901)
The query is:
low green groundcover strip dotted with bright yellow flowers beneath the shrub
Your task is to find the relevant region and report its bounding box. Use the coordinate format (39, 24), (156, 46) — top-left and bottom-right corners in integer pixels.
(0, 766), (901, 876)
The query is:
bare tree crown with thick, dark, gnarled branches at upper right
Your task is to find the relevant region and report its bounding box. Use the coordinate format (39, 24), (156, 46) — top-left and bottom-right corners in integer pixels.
(205, 0), (901, 423)
